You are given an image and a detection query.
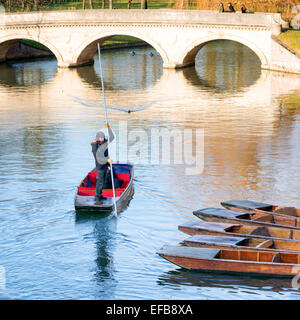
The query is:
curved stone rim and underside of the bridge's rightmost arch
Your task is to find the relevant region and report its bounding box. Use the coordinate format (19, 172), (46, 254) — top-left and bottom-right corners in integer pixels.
(179, 34), (269, 68)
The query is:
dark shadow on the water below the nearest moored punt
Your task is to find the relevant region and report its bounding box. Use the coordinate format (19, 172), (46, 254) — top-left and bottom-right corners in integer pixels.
(157, 268), (300, 296)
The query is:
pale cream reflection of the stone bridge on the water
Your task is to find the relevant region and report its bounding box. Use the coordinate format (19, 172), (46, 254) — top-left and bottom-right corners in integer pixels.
(0, 60), (300, 125)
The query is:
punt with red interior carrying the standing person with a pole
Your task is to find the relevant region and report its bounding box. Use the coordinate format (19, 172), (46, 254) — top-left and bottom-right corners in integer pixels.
(74, 163), (133, 213)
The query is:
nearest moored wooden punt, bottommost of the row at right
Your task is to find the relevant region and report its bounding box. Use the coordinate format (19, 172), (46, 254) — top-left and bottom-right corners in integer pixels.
(158, 246), (300, 277)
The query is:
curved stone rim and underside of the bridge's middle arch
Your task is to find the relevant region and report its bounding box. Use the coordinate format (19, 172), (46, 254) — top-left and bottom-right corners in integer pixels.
(70, 30), (169, 66)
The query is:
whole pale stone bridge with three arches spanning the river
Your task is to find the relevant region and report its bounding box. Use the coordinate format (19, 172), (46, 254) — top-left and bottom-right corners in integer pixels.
(0, 10), (300, 73)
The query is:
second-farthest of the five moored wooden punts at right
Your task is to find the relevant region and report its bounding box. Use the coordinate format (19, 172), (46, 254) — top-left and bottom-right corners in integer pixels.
(193, 208), (300, 230)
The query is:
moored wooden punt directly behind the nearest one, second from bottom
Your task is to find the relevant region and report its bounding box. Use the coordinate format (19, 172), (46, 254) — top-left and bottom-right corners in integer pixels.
(182, 234), (300, 253)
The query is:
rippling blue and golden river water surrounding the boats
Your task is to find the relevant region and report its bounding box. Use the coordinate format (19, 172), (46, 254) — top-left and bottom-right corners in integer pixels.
(0, 41), (300, 299)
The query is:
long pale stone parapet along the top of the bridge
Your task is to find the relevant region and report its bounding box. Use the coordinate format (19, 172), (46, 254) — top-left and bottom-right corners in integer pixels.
(0, 9), (286, 28)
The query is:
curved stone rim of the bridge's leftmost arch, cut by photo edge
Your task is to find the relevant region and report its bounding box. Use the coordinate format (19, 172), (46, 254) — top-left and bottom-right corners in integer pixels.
(0, 33), (63, 64)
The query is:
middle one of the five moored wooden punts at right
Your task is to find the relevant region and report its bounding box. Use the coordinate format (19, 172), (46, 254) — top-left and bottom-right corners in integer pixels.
(178, 221), (300, 241)
